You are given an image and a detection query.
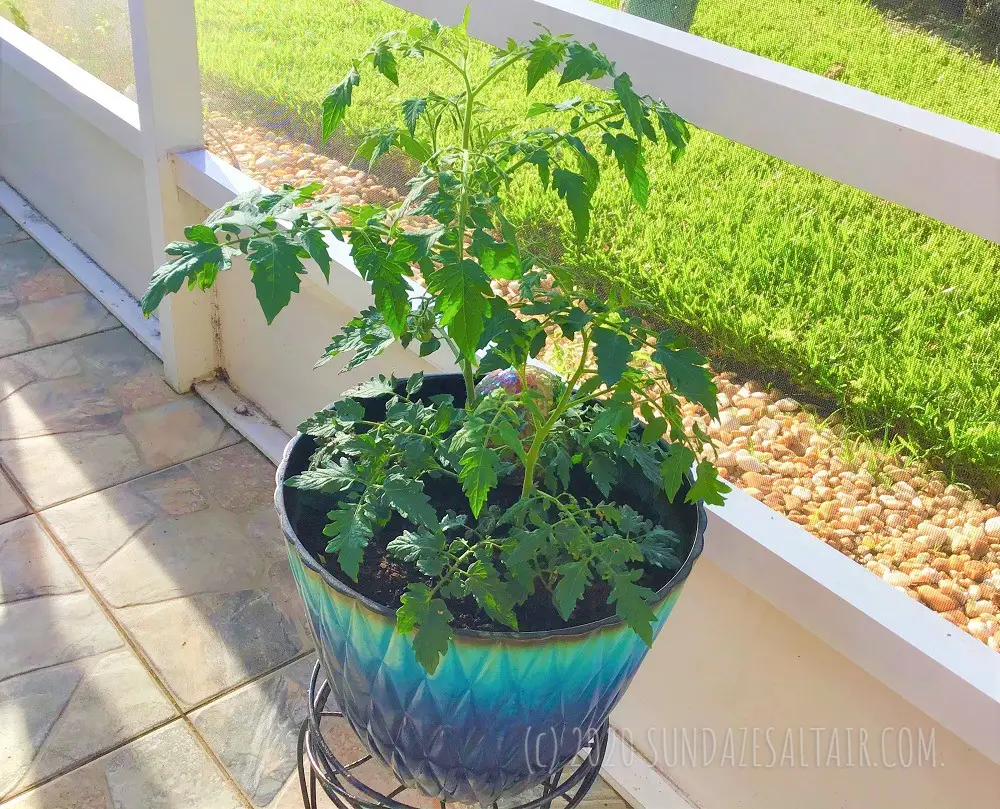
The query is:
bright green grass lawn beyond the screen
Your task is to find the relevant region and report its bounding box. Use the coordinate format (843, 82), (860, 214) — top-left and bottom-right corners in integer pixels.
(196, 0), (1000, 485)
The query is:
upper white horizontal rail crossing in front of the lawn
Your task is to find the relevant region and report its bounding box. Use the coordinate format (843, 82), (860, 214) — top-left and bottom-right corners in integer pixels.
(388, 0), (1000, 242)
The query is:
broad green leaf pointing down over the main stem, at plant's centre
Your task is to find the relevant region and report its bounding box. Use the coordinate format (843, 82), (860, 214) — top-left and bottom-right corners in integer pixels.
(427, 259), (493, 357)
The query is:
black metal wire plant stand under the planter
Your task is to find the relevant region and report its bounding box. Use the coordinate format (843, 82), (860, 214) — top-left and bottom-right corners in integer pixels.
(299, 663), (608, 809)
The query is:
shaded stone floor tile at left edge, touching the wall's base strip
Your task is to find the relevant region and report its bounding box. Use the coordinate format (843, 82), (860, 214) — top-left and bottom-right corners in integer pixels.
(0, 237), (118, 357)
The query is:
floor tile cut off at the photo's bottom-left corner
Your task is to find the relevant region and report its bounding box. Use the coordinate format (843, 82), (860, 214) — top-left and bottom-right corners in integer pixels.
(4, 720), (244, 809)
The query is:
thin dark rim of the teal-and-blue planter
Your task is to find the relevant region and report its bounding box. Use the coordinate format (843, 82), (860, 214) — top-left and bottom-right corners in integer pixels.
(274, 374), (708, 641)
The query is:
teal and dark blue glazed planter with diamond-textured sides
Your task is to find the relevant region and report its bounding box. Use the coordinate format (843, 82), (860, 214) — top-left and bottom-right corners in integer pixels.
(275, 374), (706, 805)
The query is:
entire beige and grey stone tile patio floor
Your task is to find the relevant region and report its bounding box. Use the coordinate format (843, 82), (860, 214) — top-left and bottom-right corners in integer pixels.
(0, 212), (624, 809)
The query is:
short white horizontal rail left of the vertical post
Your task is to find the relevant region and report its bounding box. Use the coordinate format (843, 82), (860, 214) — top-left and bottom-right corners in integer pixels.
(0, 18), (141, 157)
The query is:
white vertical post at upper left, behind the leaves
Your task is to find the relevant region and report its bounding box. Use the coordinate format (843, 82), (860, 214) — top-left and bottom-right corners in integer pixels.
(129, 0), (217, 391)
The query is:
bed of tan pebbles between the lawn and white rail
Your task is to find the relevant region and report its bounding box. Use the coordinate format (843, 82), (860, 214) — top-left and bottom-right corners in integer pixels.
(206, 115), (1000, 651)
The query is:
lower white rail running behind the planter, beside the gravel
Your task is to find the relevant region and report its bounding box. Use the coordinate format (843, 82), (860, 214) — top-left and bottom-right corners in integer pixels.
(175, 144), (1000, 764)
